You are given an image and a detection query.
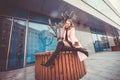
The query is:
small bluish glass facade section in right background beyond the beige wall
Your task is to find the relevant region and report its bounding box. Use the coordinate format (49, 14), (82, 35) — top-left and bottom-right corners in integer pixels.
(91, 28), (110, 52)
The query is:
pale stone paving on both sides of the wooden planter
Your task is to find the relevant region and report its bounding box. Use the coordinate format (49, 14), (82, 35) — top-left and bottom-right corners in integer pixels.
(0, 52), (120, 80)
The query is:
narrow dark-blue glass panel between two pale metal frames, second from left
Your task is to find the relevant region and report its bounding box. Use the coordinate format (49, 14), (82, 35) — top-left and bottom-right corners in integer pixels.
(8, 19), (26, 70)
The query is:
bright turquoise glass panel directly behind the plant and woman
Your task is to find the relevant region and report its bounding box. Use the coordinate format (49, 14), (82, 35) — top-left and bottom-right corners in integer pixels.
(26, 22), (57, 63)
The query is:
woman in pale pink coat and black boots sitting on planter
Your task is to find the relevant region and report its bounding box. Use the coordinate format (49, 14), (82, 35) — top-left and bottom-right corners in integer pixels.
(41, 19), (88, 67)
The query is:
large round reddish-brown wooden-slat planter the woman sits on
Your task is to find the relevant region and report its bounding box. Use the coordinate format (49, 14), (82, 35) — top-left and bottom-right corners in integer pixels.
(34, 51), (86, 80)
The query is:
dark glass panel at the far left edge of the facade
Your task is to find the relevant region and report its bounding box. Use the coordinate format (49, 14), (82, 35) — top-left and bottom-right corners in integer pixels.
(0, 17), (12, 71)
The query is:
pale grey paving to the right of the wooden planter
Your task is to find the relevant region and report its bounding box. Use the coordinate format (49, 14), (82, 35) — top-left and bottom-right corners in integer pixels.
(80, 51), (120, 80)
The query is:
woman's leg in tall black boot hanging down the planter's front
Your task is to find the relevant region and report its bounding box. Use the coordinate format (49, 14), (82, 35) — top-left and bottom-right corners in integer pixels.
(41, 41), (64, 67)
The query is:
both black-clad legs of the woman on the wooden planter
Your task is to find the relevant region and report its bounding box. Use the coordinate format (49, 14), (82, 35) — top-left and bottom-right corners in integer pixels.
(46, 41), (88, 65)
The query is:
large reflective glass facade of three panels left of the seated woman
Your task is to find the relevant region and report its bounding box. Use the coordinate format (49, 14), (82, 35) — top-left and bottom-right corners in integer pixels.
(0, 17), (57, 71)
